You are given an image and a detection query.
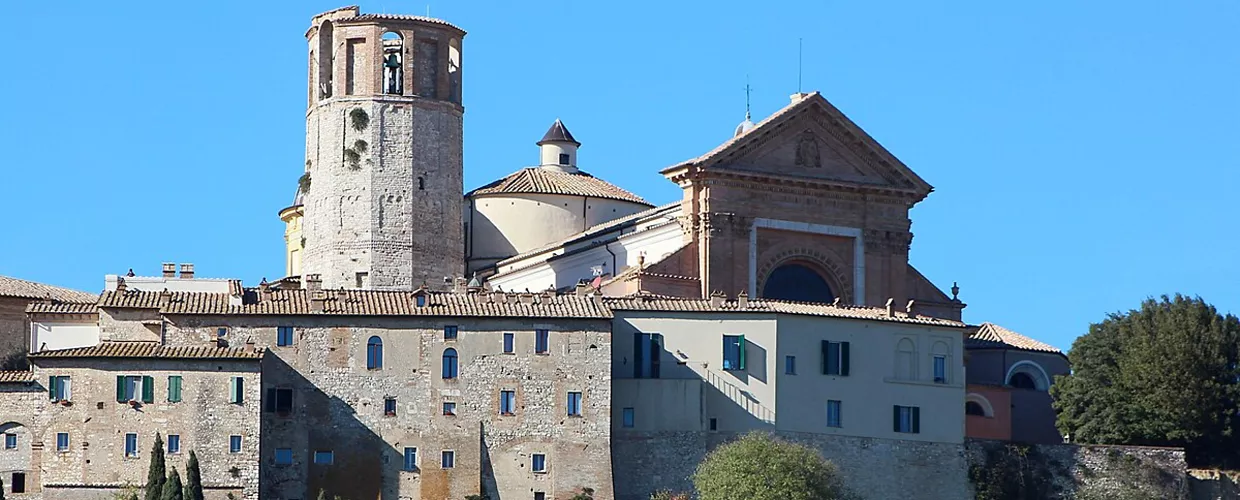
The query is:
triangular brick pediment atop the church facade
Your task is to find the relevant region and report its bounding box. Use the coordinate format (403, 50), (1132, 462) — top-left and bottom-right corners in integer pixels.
(679, 92), (932, 200)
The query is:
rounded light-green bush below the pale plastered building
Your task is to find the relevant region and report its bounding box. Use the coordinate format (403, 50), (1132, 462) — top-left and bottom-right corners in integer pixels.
(693, 432), (846, 500)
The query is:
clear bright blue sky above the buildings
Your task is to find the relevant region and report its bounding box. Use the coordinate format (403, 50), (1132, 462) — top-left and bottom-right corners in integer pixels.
(0, 0), (1240, 349)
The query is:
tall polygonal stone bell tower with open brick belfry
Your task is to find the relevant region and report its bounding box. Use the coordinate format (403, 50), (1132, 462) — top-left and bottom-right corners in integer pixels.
(301, 6), (465, 290)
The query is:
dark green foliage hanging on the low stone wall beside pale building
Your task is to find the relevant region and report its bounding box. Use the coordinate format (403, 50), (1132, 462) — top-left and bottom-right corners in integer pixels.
(968, 444), (1056, 500)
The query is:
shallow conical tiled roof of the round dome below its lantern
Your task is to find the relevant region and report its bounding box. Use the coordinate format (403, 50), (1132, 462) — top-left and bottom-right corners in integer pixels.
(465, 166), (650, 205)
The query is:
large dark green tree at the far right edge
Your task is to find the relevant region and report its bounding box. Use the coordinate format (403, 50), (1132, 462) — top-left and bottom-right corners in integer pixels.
(1050, 294), (1240, 467)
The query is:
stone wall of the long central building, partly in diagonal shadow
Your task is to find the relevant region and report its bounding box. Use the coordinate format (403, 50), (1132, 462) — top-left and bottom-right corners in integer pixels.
(166, 316), (613, 500)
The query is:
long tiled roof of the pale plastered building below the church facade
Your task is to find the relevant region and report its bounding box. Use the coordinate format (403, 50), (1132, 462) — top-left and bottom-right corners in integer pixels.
(603, 294), (967, 328)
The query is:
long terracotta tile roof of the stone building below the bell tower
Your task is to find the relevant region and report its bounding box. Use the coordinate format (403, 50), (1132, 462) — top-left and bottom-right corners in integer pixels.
(99, 288), (611, 319)
